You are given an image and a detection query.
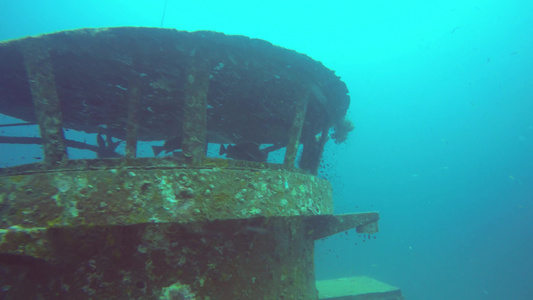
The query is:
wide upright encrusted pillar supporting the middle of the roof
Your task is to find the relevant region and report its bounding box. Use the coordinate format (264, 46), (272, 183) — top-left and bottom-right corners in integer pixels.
(182, 60), (209, 165)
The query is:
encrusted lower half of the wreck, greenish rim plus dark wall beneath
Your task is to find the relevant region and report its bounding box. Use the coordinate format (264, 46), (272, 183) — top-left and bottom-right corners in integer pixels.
(0, 166), (377, 299)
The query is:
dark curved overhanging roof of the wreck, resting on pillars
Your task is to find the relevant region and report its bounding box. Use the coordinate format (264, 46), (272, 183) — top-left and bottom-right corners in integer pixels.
(0, 27), (350, 144)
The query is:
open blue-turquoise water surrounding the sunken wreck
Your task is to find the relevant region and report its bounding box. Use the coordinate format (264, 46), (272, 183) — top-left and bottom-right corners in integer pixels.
(0, 0), (533, 300)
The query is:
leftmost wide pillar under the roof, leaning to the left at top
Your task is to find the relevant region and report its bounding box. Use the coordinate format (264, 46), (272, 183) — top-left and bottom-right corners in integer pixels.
(21, 38), (68, 165)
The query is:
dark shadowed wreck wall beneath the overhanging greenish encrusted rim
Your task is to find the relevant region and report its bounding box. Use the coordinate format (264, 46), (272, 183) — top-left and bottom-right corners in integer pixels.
(0, 217), (317, 300)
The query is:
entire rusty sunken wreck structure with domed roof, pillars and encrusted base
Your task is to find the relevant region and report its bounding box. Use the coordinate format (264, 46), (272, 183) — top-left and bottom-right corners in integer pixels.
(0, 28), (379, 299)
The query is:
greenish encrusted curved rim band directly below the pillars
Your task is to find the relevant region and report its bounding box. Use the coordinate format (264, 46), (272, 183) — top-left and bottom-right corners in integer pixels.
(0, 168), (332, 228)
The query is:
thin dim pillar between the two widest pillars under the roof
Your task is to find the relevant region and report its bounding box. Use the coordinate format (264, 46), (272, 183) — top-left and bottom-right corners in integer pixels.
(126, 80), (141, 159)
